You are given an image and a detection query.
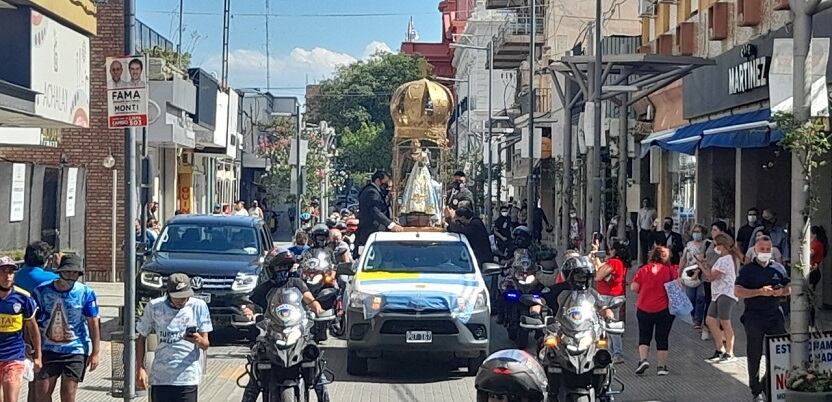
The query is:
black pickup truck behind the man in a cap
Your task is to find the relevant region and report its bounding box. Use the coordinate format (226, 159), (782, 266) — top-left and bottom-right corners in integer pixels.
(137, 215), (274, 334)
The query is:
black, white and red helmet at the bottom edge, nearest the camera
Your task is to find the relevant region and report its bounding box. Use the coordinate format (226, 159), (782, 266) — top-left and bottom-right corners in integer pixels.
(474, 349), (548, 402)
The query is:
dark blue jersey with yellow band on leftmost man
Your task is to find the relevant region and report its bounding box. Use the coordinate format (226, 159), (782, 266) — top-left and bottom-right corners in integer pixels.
(0, 286), (37, 362)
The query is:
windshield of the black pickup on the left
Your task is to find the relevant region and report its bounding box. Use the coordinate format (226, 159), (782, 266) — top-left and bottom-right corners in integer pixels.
(156, 223), (260, 255)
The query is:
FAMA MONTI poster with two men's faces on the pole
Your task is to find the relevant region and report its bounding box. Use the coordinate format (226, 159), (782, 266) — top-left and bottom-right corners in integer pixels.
(106, 56), (149, 128)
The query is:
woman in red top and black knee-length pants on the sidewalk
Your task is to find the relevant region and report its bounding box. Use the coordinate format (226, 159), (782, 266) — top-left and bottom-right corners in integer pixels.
(630, 246), (679, 376)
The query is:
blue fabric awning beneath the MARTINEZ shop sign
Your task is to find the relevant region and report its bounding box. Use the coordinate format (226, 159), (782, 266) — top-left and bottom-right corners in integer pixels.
(648, 109), (783, 155)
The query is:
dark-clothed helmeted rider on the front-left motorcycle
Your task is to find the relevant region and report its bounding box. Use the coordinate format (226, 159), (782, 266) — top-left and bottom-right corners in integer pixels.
(242, 249), (329, 402)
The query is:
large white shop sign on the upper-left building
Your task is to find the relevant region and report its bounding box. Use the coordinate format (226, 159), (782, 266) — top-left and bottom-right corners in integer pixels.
(31, 10), (90, 128)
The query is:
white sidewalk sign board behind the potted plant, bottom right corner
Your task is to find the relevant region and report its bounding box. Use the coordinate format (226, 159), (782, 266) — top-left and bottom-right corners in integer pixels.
(766, 333), (832, 402)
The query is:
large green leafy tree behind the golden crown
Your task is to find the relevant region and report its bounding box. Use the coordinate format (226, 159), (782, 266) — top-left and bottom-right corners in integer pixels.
(306, 52), (426, 178)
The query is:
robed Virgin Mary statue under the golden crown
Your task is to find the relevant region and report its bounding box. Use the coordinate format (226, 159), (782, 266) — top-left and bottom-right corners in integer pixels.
(401, 140), (440, 215)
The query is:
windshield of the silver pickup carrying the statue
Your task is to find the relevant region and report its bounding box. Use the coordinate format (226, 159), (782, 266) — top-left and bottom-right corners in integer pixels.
(362, 241), (474, 274)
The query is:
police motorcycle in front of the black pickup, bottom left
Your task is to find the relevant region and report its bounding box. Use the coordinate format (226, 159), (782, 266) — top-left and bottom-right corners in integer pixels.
(237, 287), (335, 402)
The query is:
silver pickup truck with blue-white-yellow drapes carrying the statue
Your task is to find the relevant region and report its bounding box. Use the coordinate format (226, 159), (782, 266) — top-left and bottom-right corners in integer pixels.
(339, 232), (500, 375)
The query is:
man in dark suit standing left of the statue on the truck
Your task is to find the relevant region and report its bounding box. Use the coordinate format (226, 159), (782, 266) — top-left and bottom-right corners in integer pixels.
(355, 170), (402, 253)
